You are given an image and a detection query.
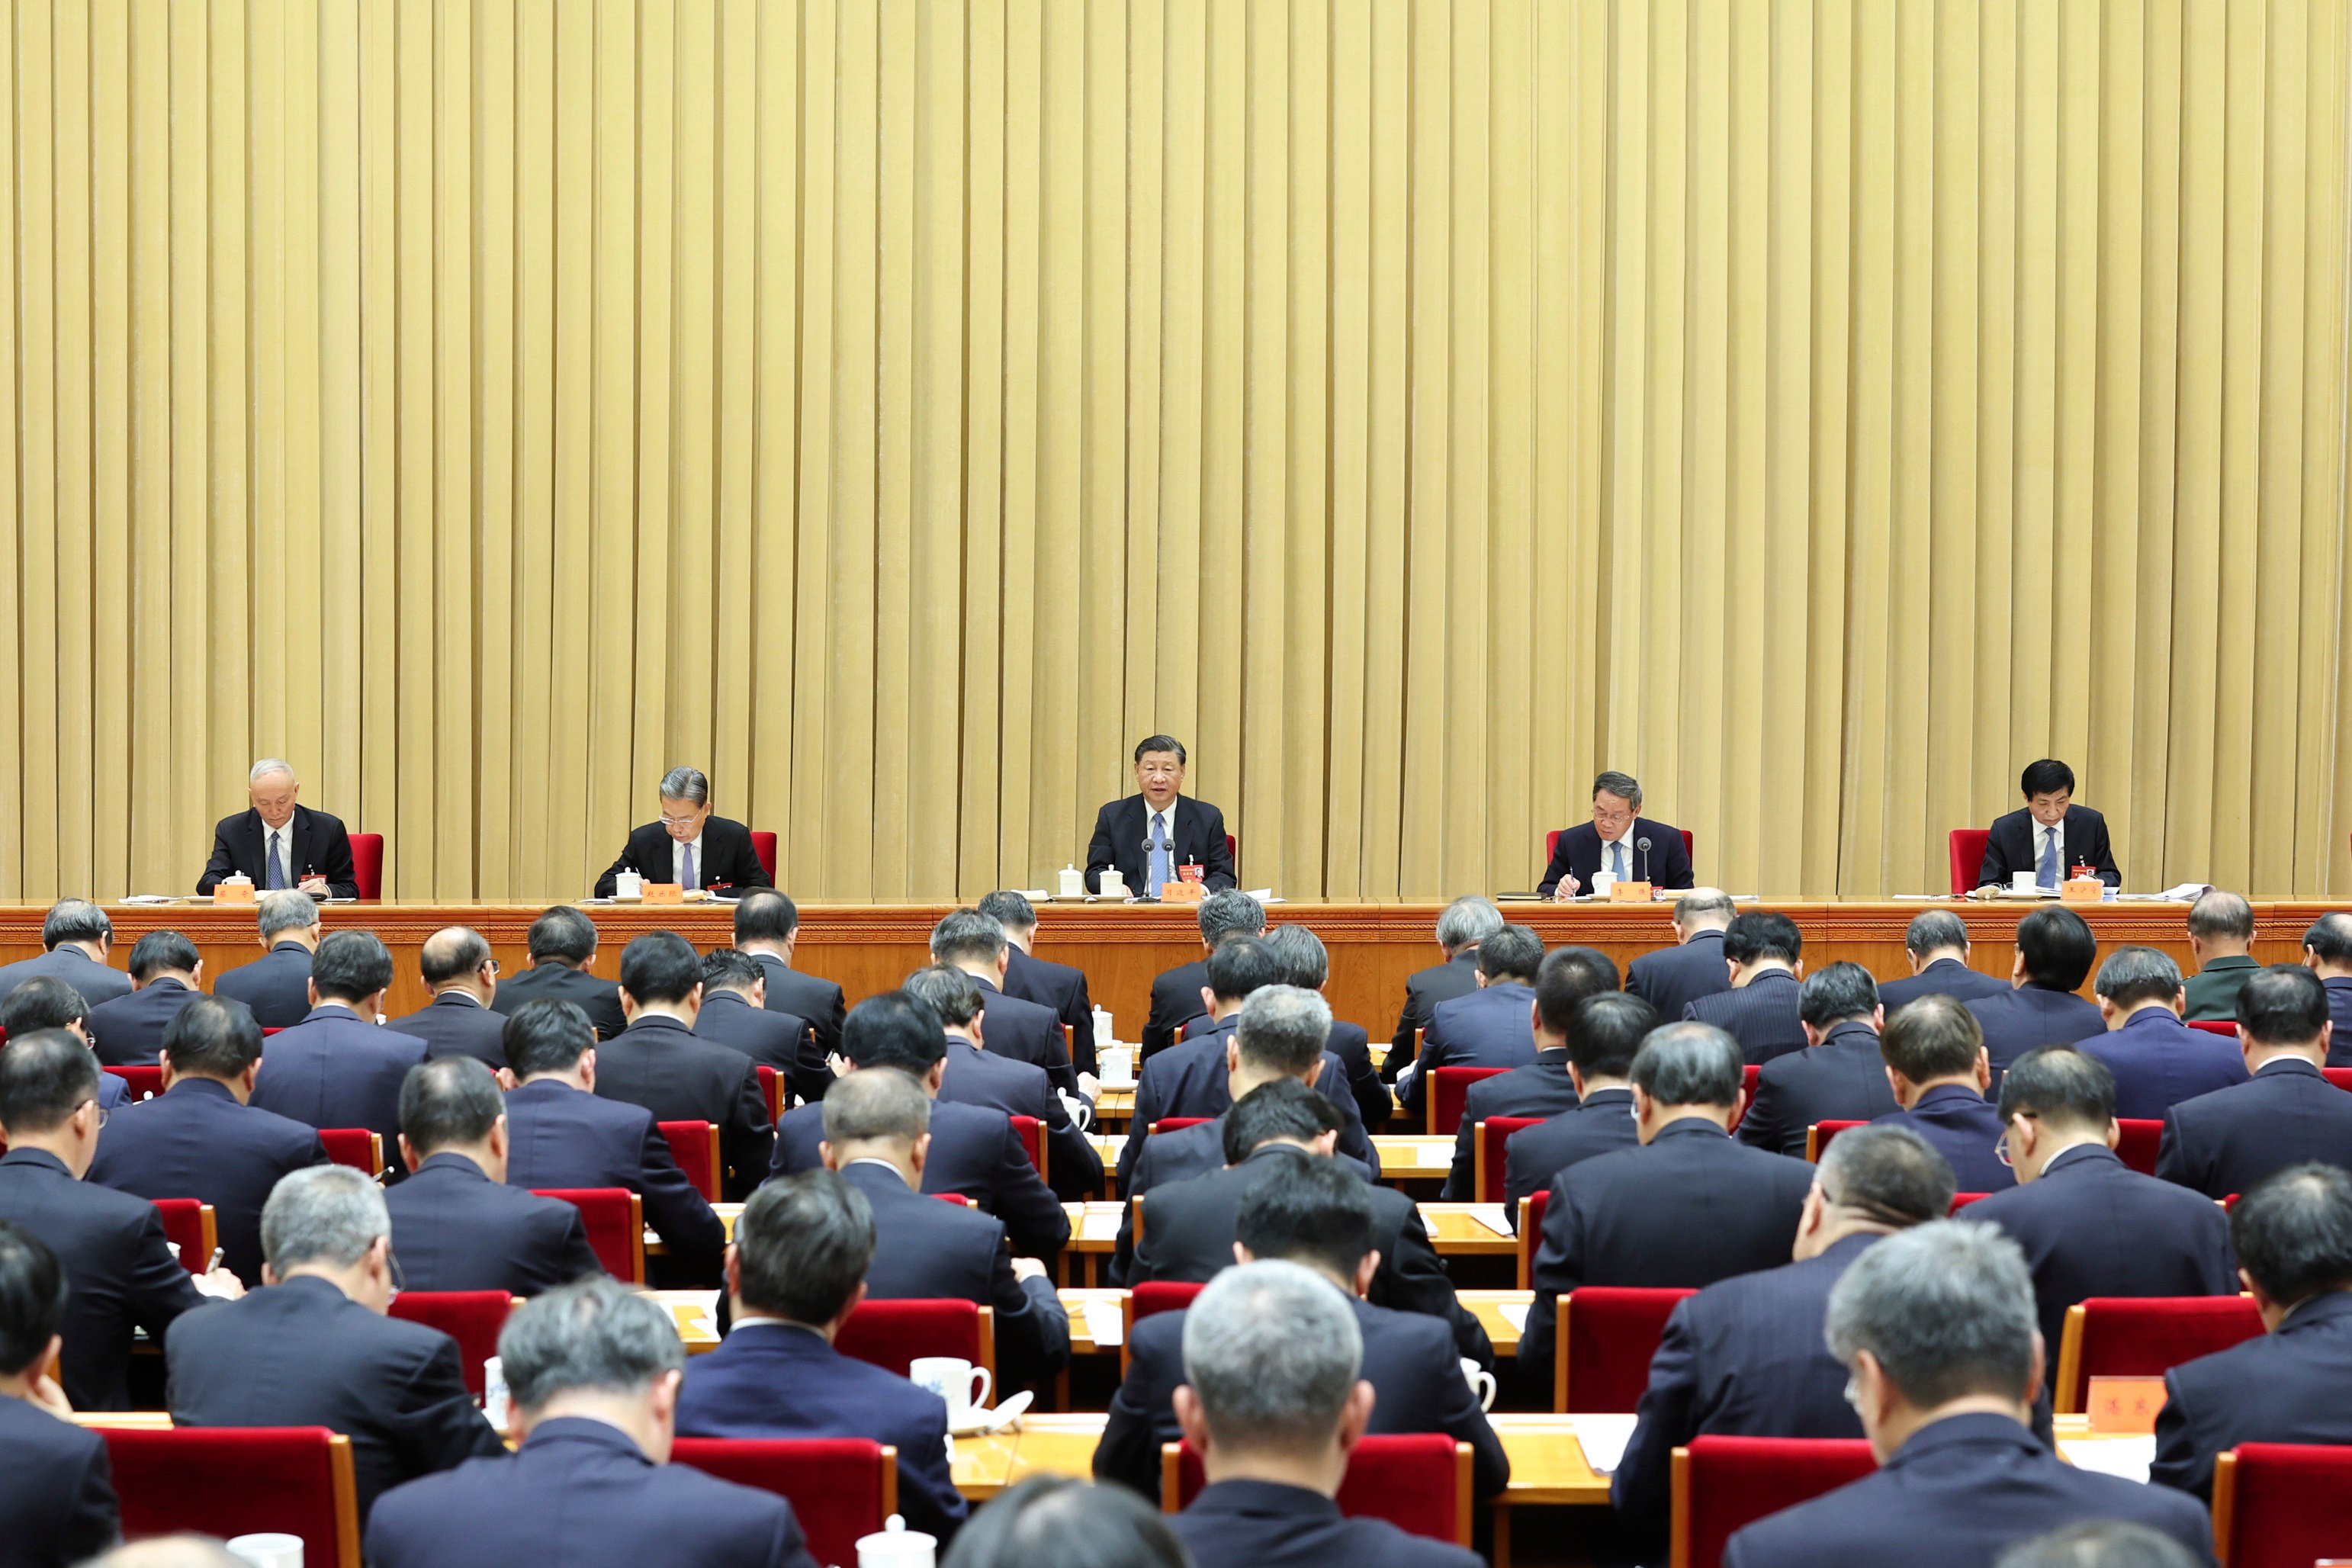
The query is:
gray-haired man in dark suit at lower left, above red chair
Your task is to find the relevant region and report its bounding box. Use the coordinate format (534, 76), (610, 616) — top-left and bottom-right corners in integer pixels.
(165, 1166), (506, 1521)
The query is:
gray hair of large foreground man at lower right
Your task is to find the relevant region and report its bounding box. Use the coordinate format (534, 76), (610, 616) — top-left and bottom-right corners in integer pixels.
(1823, 1222), (2035, 1410)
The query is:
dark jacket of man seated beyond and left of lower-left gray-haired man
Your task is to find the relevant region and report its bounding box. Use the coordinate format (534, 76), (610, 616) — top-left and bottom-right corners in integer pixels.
(89, 1079), (331, 1286)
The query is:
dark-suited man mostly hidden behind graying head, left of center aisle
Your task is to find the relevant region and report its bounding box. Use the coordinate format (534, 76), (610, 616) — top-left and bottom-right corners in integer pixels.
(769, 992), (1070, 1258)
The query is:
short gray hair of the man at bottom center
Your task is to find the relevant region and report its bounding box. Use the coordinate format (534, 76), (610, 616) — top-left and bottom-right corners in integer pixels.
(1183, 1262), (1364, 1453)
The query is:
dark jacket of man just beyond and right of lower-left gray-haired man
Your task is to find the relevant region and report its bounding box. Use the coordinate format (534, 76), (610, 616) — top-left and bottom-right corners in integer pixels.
(384, 1154), (605, 1295)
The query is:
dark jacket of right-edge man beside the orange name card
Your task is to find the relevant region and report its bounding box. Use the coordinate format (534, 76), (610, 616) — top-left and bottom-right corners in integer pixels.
(2148, 1290), (2352, 1498)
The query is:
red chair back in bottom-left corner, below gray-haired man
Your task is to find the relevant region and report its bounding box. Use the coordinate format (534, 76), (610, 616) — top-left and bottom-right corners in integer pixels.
(99, 1427), (360, 1568)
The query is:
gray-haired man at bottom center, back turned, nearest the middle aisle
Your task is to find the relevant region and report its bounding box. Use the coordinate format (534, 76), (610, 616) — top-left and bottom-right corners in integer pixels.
(1169, 1262), (1482, 1568)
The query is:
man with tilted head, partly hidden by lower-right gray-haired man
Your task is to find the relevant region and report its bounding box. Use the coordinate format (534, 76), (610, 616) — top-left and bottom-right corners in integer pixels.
(1608, 1126), (1952, 1561)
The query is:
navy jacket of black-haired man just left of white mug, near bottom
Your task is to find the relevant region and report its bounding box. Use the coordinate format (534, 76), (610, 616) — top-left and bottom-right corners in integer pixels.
(682, 1316), (969, 1542)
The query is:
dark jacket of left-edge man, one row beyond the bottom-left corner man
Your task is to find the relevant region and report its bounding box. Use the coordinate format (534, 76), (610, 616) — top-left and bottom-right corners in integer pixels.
(0, 1147), (204, 1410)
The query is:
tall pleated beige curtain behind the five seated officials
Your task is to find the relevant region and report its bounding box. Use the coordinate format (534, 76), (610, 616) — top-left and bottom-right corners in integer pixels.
(0, 0), (2352, 901)
